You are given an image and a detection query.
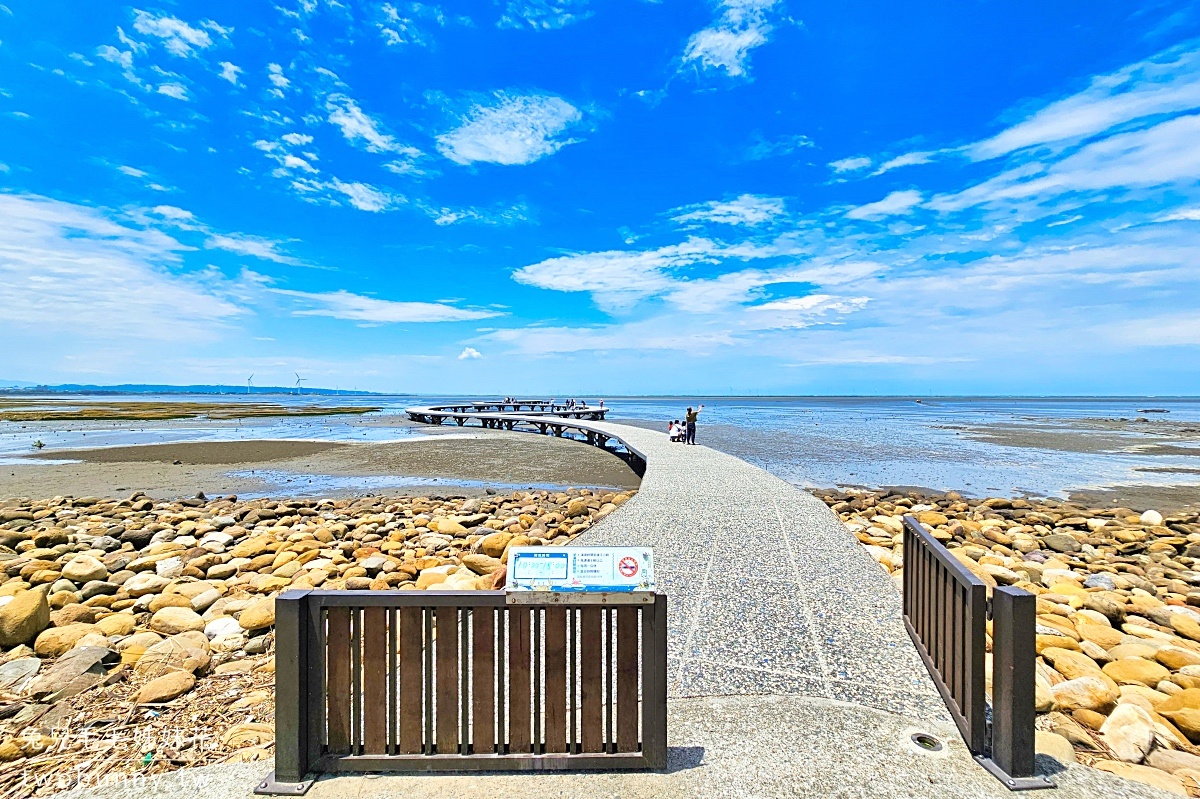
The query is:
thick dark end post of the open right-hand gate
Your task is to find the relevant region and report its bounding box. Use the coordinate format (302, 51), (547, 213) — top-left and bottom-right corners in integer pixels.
(979, 585), (1054, 791)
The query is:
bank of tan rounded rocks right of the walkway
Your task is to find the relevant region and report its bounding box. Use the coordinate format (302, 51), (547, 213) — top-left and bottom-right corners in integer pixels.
(816, 491), (1200, 797)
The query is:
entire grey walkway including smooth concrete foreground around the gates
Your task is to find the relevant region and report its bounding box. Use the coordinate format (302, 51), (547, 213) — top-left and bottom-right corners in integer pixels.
(51, 422), (1171, 799)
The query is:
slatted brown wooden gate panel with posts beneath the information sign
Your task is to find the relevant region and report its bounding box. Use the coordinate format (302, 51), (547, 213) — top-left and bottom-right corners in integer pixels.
(256, 590), (667, 795)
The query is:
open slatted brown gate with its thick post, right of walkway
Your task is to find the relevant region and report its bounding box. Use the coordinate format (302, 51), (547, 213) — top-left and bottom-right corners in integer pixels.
(904, 516), (1054, 791)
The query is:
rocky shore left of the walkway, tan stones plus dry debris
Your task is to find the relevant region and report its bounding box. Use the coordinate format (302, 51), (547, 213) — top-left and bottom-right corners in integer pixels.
(0, 488), (634, 799)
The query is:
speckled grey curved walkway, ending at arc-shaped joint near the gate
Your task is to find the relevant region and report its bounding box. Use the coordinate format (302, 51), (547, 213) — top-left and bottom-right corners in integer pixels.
(576, 422), (949, 721)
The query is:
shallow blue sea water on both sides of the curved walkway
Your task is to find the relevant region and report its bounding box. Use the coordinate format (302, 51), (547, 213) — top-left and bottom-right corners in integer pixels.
(0, 395), (1200, 495)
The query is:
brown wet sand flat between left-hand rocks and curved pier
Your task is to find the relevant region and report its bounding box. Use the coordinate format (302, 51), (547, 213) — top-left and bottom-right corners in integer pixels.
(0, 431), (640, 499)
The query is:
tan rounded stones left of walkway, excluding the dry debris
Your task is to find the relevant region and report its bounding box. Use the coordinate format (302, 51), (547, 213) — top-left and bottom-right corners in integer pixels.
(0, 488), (634, 767)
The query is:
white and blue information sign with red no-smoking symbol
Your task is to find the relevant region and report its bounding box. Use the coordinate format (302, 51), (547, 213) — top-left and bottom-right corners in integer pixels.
(506, 547), (654, 591)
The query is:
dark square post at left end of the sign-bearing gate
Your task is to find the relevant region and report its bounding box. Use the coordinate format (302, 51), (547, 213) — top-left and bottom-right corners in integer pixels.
(254, 590), (313, 795)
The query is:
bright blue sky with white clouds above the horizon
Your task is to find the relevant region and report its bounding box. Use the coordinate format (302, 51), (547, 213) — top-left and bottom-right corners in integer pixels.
(0, 0), (1200, 395)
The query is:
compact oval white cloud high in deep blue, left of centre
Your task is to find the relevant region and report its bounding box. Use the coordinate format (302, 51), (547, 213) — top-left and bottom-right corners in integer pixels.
(437, 91), (583, 166)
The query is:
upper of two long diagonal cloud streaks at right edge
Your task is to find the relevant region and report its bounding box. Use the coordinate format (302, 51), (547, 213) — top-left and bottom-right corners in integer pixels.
(966, 42), (1200, 160)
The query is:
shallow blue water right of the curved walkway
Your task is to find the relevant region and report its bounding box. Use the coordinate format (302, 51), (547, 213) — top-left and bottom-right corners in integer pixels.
(611, 397), (1200, 497)
